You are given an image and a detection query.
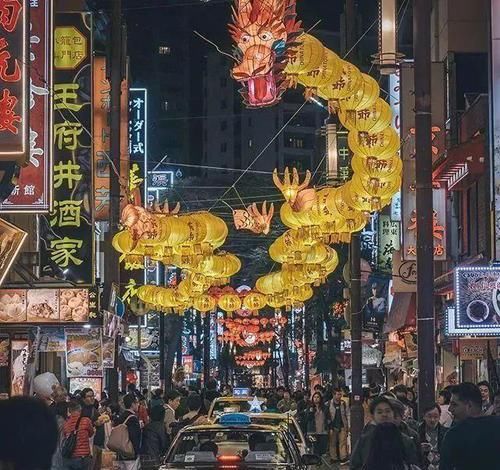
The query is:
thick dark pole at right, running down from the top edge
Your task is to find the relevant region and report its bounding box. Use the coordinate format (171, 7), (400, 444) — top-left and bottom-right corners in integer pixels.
(413, 0), (435, 417)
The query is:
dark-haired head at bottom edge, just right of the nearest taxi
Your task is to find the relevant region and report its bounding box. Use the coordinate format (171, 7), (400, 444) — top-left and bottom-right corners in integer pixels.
(363, 422), (419, 470)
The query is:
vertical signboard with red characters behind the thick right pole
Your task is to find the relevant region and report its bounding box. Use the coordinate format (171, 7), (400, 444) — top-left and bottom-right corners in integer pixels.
(401, 62), (446, 261)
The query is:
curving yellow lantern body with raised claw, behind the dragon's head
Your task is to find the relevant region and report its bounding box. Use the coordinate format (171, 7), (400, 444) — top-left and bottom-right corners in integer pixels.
(256, 34), (402, 309)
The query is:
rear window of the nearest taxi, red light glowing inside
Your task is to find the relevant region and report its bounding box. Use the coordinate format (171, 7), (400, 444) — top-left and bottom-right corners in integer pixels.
(167, 428), (293, 466)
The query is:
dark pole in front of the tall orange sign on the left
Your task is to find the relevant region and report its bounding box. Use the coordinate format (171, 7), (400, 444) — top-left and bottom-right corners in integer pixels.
(104, 0), (123, 403)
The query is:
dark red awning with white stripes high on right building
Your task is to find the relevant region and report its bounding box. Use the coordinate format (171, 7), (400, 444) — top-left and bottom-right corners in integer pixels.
(432, 135), (486, 191)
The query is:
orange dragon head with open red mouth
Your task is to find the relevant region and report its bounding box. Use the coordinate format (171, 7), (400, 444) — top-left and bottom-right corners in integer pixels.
(229, 0), (302, 108)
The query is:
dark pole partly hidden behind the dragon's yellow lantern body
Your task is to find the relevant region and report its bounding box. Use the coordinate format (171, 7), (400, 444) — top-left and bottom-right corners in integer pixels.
(345, 0), (364, 449)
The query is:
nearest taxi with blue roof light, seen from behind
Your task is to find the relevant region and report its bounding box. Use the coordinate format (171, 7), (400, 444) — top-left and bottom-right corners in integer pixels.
(160, 413), (320, 470)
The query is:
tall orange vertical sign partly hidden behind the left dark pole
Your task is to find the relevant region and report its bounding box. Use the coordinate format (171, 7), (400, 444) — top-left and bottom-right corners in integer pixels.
(93, 57), (129, 221)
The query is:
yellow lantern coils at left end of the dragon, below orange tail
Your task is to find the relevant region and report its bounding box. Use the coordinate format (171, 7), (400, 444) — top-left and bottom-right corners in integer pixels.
(113, 204), (241, 313)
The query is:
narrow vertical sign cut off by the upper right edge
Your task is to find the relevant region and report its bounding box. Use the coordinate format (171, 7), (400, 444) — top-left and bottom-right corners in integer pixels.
(489, 0), (500, 261)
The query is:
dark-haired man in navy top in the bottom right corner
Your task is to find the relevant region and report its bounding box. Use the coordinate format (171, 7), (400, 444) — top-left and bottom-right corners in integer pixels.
(439, 382), (500, 470)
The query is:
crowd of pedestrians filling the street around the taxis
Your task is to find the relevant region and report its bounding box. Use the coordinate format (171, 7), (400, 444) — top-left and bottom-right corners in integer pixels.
(0, 380), (500, 470)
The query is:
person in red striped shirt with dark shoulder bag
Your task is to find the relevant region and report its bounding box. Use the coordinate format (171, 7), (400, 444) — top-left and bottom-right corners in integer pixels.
(63, 401), (94, 470)
